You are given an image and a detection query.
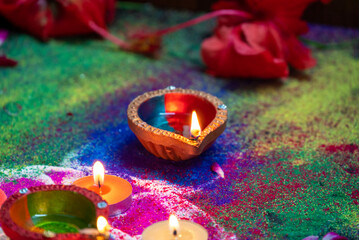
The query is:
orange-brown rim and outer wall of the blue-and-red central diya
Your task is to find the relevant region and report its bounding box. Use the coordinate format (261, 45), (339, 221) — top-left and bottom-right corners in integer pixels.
(127, 86), (228, 161)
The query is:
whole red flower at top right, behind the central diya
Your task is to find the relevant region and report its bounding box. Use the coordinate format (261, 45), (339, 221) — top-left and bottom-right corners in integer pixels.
(201, 0), (328, 78)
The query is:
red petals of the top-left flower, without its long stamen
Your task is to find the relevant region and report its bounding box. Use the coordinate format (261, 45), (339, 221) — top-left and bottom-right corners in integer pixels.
(0, 0), (115, 40)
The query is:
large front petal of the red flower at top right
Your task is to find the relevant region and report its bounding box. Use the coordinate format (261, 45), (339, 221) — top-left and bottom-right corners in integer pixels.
(201, 23), (288, 78)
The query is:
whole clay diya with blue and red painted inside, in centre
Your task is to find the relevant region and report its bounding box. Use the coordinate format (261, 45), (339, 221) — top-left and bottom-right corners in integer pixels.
(127, 86), (227, 161)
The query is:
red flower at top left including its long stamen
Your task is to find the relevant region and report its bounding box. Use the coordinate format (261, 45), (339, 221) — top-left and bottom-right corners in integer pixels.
(0, 0), (153, 54)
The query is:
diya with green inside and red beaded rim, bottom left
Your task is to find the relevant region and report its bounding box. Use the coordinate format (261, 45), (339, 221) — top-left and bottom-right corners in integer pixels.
(0, 185), (109, 240)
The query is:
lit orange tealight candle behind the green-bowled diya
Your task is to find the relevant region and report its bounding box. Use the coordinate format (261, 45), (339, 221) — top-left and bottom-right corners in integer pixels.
(73, 161), (132, 217)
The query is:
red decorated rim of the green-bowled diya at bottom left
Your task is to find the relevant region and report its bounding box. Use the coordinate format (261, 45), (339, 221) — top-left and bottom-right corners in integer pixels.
(0, 185), (109, 240)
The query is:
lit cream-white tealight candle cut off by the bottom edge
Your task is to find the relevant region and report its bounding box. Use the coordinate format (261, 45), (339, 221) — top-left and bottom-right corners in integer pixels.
(142, 215), (208, 240)
